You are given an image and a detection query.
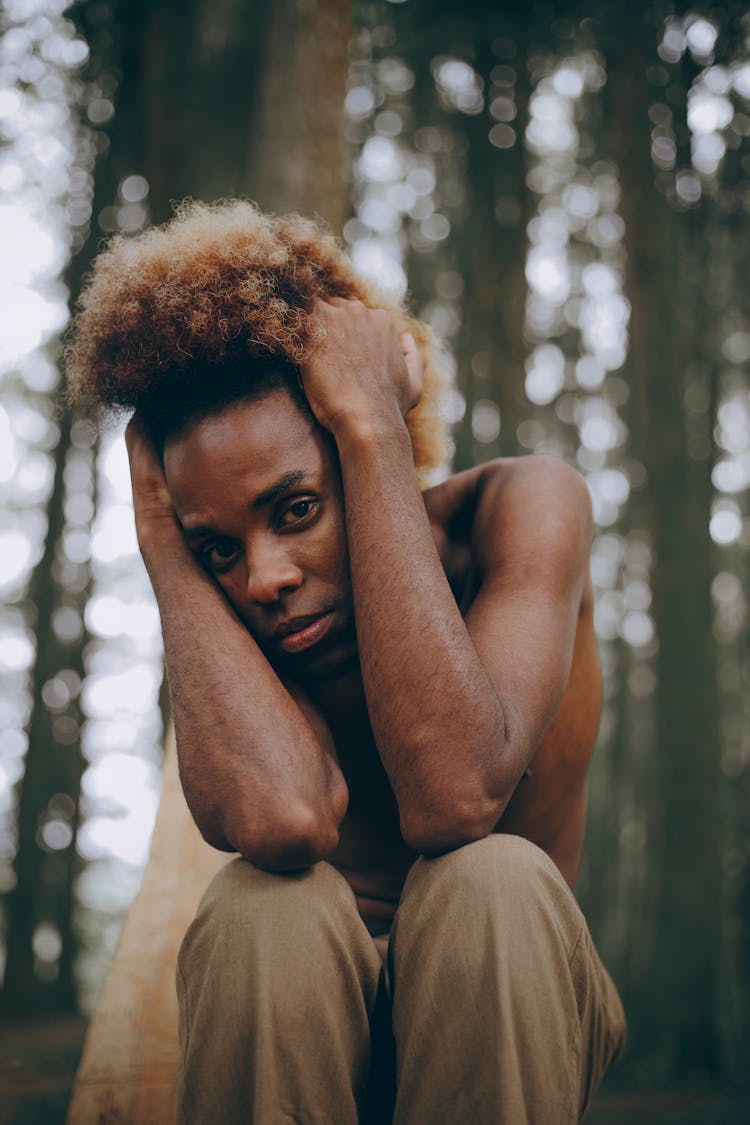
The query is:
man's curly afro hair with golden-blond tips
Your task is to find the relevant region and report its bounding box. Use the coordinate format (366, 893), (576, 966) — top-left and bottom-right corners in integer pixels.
(65, 199), (446, 476)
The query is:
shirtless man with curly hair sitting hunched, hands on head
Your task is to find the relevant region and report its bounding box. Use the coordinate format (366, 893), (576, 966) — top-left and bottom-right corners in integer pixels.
(69, 204), (624, 1125)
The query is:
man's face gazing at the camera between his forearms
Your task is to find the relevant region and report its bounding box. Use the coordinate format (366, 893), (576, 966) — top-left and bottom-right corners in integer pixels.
(164, 390), (356, 680)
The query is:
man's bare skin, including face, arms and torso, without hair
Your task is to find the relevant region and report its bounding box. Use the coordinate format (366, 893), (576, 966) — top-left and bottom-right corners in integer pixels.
(127, 302), (600, 933)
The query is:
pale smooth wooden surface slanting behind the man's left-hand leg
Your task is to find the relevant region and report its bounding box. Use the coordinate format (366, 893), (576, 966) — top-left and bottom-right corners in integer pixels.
(67, 735), (231, 1125)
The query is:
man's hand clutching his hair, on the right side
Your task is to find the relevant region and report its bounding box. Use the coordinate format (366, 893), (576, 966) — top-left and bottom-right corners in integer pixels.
(300, 297), (424, 435)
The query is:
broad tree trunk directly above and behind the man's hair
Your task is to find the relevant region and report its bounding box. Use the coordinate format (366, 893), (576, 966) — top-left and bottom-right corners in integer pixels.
(103, 0), (351, 231)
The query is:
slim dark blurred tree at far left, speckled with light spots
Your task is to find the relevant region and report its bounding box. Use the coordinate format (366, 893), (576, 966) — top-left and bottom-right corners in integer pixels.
(0, 0), (123, 1016)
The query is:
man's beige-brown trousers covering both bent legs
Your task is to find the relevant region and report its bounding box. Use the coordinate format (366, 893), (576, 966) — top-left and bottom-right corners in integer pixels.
(178, 835), (625, 1125)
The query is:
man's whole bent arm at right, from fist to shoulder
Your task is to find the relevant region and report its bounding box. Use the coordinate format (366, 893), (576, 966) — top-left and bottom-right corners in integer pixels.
(302, 302), (590, 853)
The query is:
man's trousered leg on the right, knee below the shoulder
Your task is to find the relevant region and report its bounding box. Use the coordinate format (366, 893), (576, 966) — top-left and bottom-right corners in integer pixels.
(389, 835), (624, 1125)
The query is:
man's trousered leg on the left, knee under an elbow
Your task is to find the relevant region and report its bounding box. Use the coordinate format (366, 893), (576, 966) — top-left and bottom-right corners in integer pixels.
(178, 860), (383, 1125)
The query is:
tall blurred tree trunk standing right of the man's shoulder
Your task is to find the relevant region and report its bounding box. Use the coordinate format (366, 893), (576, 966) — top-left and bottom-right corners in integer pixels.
(608, 26), (721, 1082)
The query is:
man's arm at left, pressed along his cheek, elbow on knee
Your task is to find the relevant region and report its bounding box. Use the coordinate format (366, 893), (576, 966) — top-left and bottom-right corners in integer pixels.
(126, 423), (347, 871)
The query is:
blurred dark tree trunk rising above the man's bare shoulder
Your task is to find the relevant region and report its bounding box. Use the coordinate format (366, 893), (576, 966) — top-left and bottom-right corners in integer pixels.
(386, 0), (533, 470)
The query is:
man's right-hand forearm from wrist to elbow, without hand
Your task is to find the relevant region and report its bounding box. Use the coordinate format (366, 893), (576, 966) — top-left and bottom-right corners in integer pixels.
(335, 417), (509, 849)
